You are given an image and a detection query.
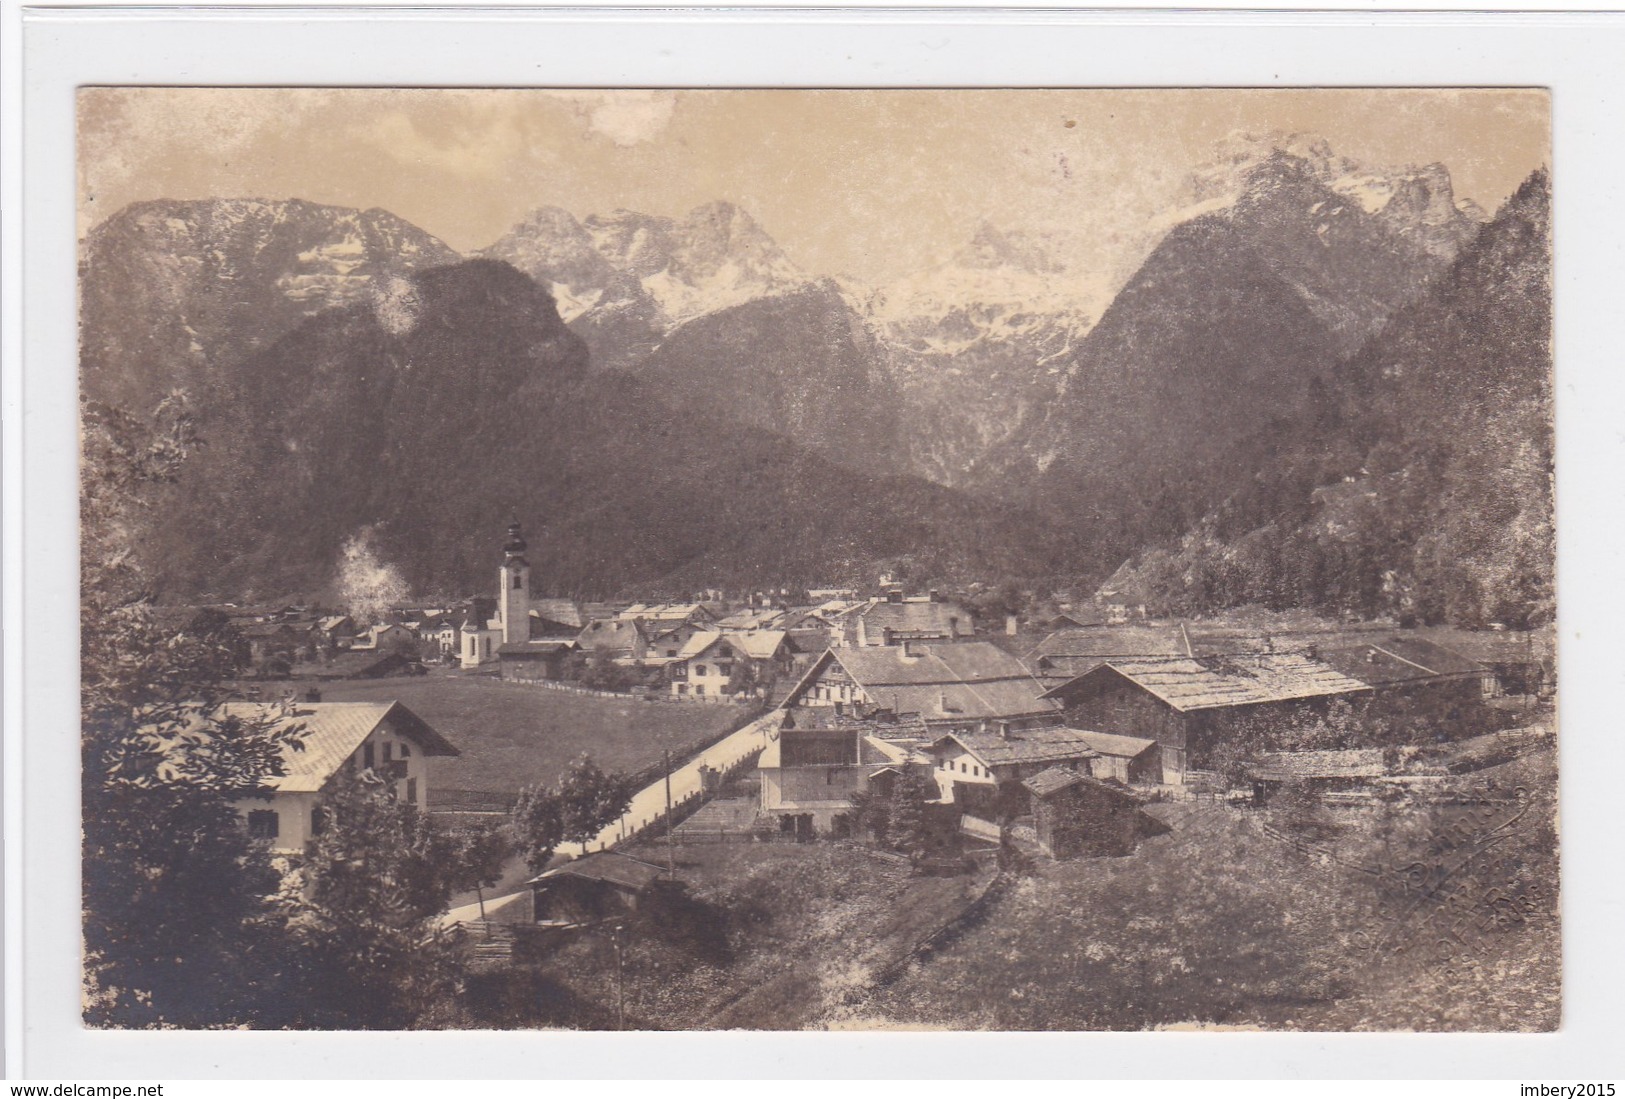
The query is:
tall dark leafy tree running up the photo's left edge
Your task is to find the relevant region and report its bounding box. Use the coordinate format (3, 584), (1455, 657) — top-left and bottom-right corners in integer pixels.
(80, 393), (299, 1027)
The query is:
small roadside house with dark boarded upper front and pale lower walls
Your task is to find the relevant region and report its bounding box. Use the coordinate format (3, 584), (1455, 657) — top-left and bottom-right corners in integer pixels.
(756, 720), (910, 839)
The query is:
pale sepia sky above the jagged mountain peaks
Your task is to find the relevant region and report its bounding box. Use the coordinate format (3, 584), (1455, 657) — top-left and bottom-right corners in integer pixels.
(78, 88), (1550, 283)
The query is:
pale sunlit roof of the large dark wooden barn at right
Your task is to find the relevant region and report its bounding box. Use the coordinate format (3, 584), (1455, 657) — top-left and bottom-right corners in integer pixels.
(1043, 652), (1372, 714)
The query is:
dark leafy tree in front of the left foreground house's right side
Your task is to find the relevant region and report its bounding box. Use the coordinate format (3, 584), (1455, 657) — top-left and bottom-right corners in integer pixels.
(284, 771), (460, 1031)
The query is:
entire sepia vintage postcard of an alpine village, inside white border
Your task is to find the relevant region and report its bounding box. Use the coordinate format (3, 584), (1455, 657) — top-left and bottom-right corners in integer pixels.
(78, 88), (1562, 1031)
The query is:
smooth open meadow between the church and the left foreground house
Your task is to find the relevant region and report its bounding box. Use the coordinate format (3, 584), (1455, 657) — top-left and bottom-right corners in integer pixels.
(274, 673), (743, 803)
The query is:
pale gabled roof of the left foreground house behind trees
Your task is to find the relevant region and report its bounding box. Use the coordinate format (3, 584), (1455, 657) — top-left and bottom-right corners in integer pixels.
(218, 702), (458, 793)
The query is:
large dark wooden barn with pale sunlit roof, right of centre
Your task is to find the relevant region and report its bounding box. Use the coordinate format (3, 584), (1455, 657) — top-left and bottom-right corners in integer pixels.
(1043, 652), (1372, 782)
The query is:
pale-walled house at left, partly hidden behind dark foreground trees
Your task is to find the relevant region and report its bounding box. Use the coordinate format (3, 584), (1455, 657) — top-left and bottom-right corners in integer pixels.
(216, 702), (458, 854)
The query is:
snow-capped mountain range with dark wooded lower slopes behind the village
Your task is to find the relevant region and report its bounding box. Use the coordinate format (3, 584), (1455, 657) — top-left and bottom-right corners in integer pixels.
(81, 138), (1550, 618)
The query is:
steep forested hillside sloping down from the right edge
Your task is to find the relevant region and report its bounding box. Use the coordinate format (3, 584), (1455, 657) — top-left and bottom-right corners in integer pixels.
(1110, 172), (1554, 626)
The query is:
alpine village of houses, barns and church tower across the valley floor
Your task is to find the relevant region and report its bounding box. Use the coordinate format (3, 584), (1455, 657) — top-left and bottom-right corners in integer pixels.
(174, 520), (1555, 1027)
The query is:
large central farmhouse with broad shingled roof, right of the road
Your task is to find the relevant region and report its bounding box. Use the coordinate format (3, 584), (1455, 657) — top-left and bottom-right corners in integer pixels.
(783, 641), (1058, 732)
